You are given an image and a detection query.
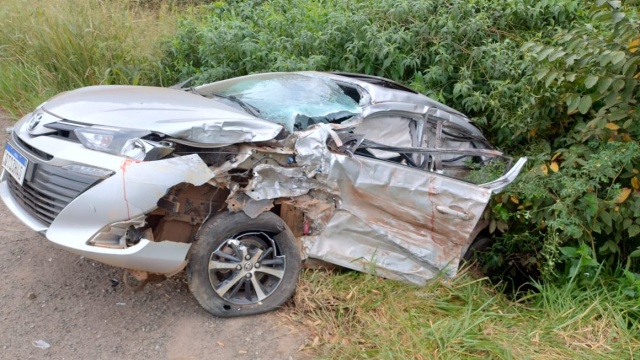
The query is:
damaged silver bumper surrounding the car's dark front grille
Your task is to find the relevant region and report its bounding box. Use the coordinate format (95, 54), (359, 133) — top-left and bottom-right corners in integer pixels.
(0, 122), (212, 274)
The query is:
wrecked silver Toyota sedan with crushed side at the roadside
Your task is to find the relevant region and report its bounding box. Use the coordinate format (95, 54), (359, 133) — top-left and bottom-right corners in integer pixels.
(0, 72), (526, 317)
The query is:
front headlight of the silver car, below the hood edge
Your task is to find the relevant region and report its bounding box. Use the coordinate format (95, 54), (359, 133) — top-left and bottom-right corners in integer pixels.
(73, 127), (173, 160)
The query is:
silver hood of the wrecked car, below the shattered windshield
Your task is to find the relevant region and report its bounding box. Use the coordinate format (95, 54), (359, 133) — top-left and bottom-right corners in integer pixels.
(42, 85), (282, 144)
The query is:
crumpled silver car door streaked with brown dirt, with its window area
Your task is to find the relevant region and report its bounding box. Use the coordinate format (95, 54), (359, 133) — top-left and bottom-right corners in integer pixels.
(306, 111), (500, 285)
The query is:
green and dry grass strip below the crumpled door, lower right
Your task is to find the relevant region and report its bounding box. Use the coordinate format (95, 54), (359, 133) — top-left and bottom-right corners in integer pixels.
(294, 270), (640, 359)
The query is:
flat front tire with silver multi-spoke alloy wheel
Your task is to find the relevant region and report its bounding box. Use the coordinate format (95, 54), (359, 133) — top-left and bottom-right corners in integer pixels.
(187, 212), (302, 317)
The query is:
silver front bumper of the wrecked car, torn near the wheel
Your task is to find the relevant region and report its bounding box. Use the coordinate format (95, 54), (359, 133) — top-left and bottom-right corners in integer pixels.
(0, 121), (213, 274)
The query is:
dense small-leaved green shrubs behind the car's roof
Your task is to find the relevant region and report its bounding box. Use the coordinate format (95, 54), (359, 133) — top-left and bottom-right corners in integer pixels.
(164, 0), (581, 145)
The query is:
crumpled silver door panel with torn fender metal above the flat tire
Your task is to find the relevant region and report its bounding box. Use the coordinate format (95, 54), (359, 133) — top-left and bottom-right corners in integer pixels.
(245, 124), (491, 285)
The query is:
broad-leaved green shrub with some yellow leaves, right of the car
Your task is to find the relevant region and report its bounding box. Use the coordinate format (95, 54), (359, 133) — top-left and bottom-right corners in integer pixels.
(487, 0), (640, 286)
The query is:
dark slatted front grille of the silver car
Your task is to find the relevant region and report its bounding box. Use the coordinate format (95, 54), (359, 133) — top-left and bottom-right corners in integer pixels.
(6, 146), (101, 225)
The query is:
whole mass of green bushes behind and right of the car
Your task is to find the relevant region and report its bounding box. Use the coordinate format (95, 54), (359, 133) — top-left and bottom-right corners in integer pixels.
(163, 0), (640, 286)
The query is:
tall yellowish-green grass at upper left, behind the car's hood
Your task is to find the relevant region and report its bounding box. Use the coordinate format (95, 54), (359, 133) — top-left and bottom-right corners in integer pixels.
(0, 0), (177, 117)
